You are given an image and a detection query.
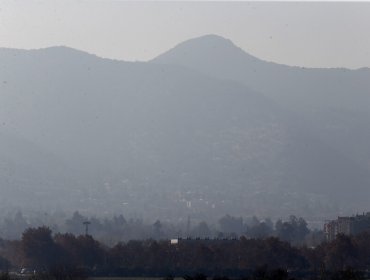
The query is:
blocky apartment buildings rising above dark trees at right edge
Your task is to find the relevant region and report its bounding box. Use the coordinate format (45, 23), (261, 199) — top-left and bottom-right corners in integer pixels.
(324, 212), (370, 241)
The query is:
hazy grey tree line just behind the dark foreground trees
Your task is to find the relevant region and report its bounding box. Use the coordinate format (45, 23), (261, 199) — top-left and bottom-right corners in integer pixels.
(0, 212), (323, 246)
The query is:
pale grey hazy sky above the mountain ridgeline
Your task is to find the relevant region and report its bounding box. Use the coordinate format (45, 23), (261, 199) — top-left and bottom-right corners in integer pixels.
(0, 0), (370, 68)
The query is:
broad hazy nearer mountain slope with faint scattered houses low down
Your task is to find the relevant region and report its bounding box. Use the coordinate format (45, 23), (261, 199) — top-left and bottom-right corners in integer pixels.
(0, 41), (370, 221)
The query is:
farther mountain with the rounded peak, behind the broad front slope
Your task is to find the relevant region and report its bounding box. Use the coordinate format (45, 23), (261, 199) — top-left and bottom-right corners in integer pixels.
(152, 32), (370, 186)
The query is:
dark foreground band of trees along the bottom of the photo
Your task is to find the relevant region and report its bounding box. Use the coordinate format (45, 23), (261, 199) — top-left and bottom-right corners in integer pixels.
(0, 227), (370, 279)
